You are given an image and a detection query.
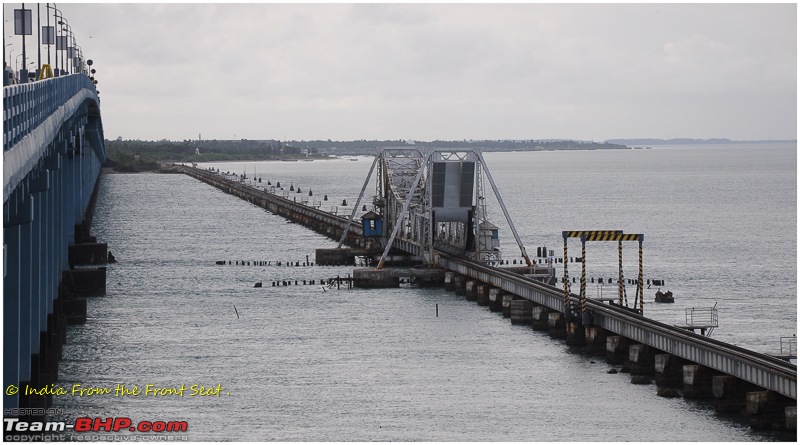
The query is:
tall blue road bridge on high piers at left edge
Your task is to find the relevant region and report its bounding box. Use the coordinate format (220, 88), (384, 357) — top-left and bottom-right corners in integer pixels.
(3, 71), (107, 415)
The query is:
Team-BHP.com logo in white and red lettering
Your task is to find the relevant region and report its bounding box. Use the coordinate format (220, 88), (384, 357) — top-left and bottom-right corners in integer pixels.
(3, 417), (189, 433)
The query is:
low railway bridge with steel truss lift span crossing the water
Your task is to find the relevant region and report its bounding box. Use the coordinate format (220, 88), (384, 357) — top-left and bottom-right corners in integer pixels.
(173, 148), (797, 429)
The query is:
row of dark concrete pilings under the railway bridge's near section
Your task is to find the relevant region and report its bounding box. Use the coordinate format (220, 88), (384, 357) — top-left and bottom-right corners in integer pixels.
(444, 272), (797, 431)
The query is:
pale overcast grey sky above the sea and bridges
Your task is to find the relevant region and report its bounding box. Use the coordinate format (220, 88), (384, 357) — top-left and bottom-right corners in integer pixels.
(3, 3), (797, 141)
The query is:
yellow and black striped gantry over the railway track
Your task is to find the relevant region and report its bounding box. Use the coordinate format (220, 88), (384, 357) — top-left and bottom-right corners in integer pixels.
(561, 230), (644, 320)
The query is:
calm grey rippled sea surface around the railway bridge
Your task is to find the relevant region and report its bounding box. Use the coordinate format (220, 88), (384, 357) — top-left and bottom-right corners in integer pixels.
(54, 144), (797, 441)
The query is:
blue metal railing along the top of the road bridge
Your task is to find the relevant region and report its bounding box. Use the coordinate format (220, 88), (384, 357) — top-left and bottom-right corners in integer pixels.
(3, 74), (97, 152)
